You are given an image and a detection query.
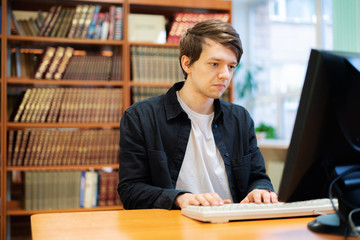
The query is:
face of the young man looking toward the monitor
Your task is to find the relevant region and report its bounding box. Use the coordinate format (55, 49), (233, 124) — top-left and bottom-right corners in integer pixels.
(182, 39), (237, 99)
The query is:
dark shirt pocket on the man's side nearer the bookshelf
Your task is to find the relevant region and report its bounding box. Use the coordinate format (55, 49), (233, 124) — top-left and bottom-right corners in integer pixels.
(148, 150), (173, 188)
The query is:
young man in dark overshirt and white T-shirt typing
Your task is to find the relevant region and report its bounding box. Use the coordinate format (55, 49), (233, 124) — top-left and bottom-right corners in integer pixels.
(118, 20), (277, 209)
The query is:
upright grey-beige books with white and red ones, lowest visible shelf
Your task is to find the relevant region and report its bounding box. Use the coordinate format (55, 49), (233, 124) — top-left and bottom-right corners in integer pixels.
(24, 170), (121, 210)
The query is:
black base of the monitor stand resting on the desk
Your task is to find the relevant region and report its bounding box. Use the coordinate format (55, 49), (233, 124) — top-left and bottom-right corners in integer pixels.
(308, 213), (355, 236)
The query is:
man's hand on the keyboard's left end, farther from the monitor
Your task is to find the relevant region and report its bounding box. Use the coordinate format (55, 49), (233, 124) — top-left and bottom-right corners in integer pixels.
(175, 193), (231, 208)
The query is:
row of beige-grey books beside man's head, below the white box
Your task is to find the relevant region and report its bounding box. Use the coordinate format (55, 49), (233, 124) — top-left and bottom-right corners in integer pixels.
(131, 46), (184, 83)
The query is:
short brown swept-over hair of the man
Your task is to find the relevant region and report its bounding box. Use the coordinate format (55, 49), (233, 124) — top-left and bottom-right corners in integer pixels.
(179, 19), (243, 79)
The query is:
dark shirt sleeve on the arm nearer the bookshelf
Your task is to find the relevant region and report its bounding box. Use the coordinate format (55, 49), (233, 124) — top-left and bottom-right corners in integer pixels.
(117, 111), (185, 209)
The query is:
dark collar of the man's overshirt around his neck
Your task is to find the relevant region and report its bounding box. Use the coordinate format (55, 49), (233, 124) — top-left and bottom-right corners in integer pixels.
(164, 81), (223, 121)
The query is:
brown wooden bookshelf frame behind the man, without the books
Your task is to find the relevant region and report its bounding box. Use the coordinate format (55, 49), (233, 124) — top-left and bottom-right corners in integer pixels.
(0, 0), (232, 239)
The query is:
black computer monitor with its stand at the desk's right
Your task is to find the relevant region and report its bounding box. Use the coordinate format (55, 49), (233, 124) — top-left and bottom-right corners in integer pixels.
(279, 50), (360, 235)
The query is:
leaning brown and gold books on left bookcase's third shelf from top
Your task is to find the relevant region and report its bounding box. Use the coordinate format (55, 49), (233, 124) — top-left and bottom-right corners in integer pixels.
(12, 87), (122, 123)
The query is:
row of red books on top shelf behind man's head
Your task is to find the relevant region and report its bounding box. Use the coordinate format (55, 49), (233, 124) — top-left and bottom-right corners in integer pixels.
(167, 12), (230, 43)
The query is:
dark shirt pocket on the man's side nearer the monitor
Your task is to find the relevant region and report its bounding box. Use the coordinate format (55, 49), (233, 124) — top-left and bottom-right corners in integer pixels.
(232, 154), (251, 195)
